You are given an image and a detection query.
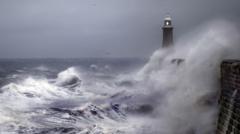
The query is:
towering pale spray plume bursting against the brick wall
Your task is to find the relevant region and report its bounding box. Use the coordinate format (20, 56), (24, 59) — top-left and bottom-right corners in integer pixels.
(133, 21), (240, 134)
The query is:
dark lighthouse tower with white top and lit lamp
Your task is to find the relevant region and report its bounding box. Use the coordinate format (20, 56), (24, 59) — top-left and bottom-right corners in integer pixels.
(162, 15), (173, 48)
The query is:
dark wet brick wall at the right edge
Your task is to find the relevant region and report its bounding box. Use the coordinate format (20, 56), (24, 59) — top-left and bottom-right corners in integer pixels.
(217, 60), (240, 134)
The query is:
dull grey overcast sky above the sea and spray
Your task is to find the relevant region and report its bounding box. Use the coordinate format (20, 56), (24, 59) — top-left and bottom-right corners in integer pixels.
(0, 0), (240, 58)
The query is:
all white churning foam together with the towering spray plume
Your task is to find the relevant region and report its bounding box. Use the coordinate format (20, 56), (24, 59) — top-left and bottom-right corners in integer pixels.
(0, 21), (240, 134)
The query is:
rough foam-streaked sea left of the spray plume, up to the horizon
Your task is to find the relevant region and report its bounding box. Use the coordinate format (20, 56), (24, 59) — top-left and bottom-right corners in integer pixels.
(0, 58), (147, 134)
